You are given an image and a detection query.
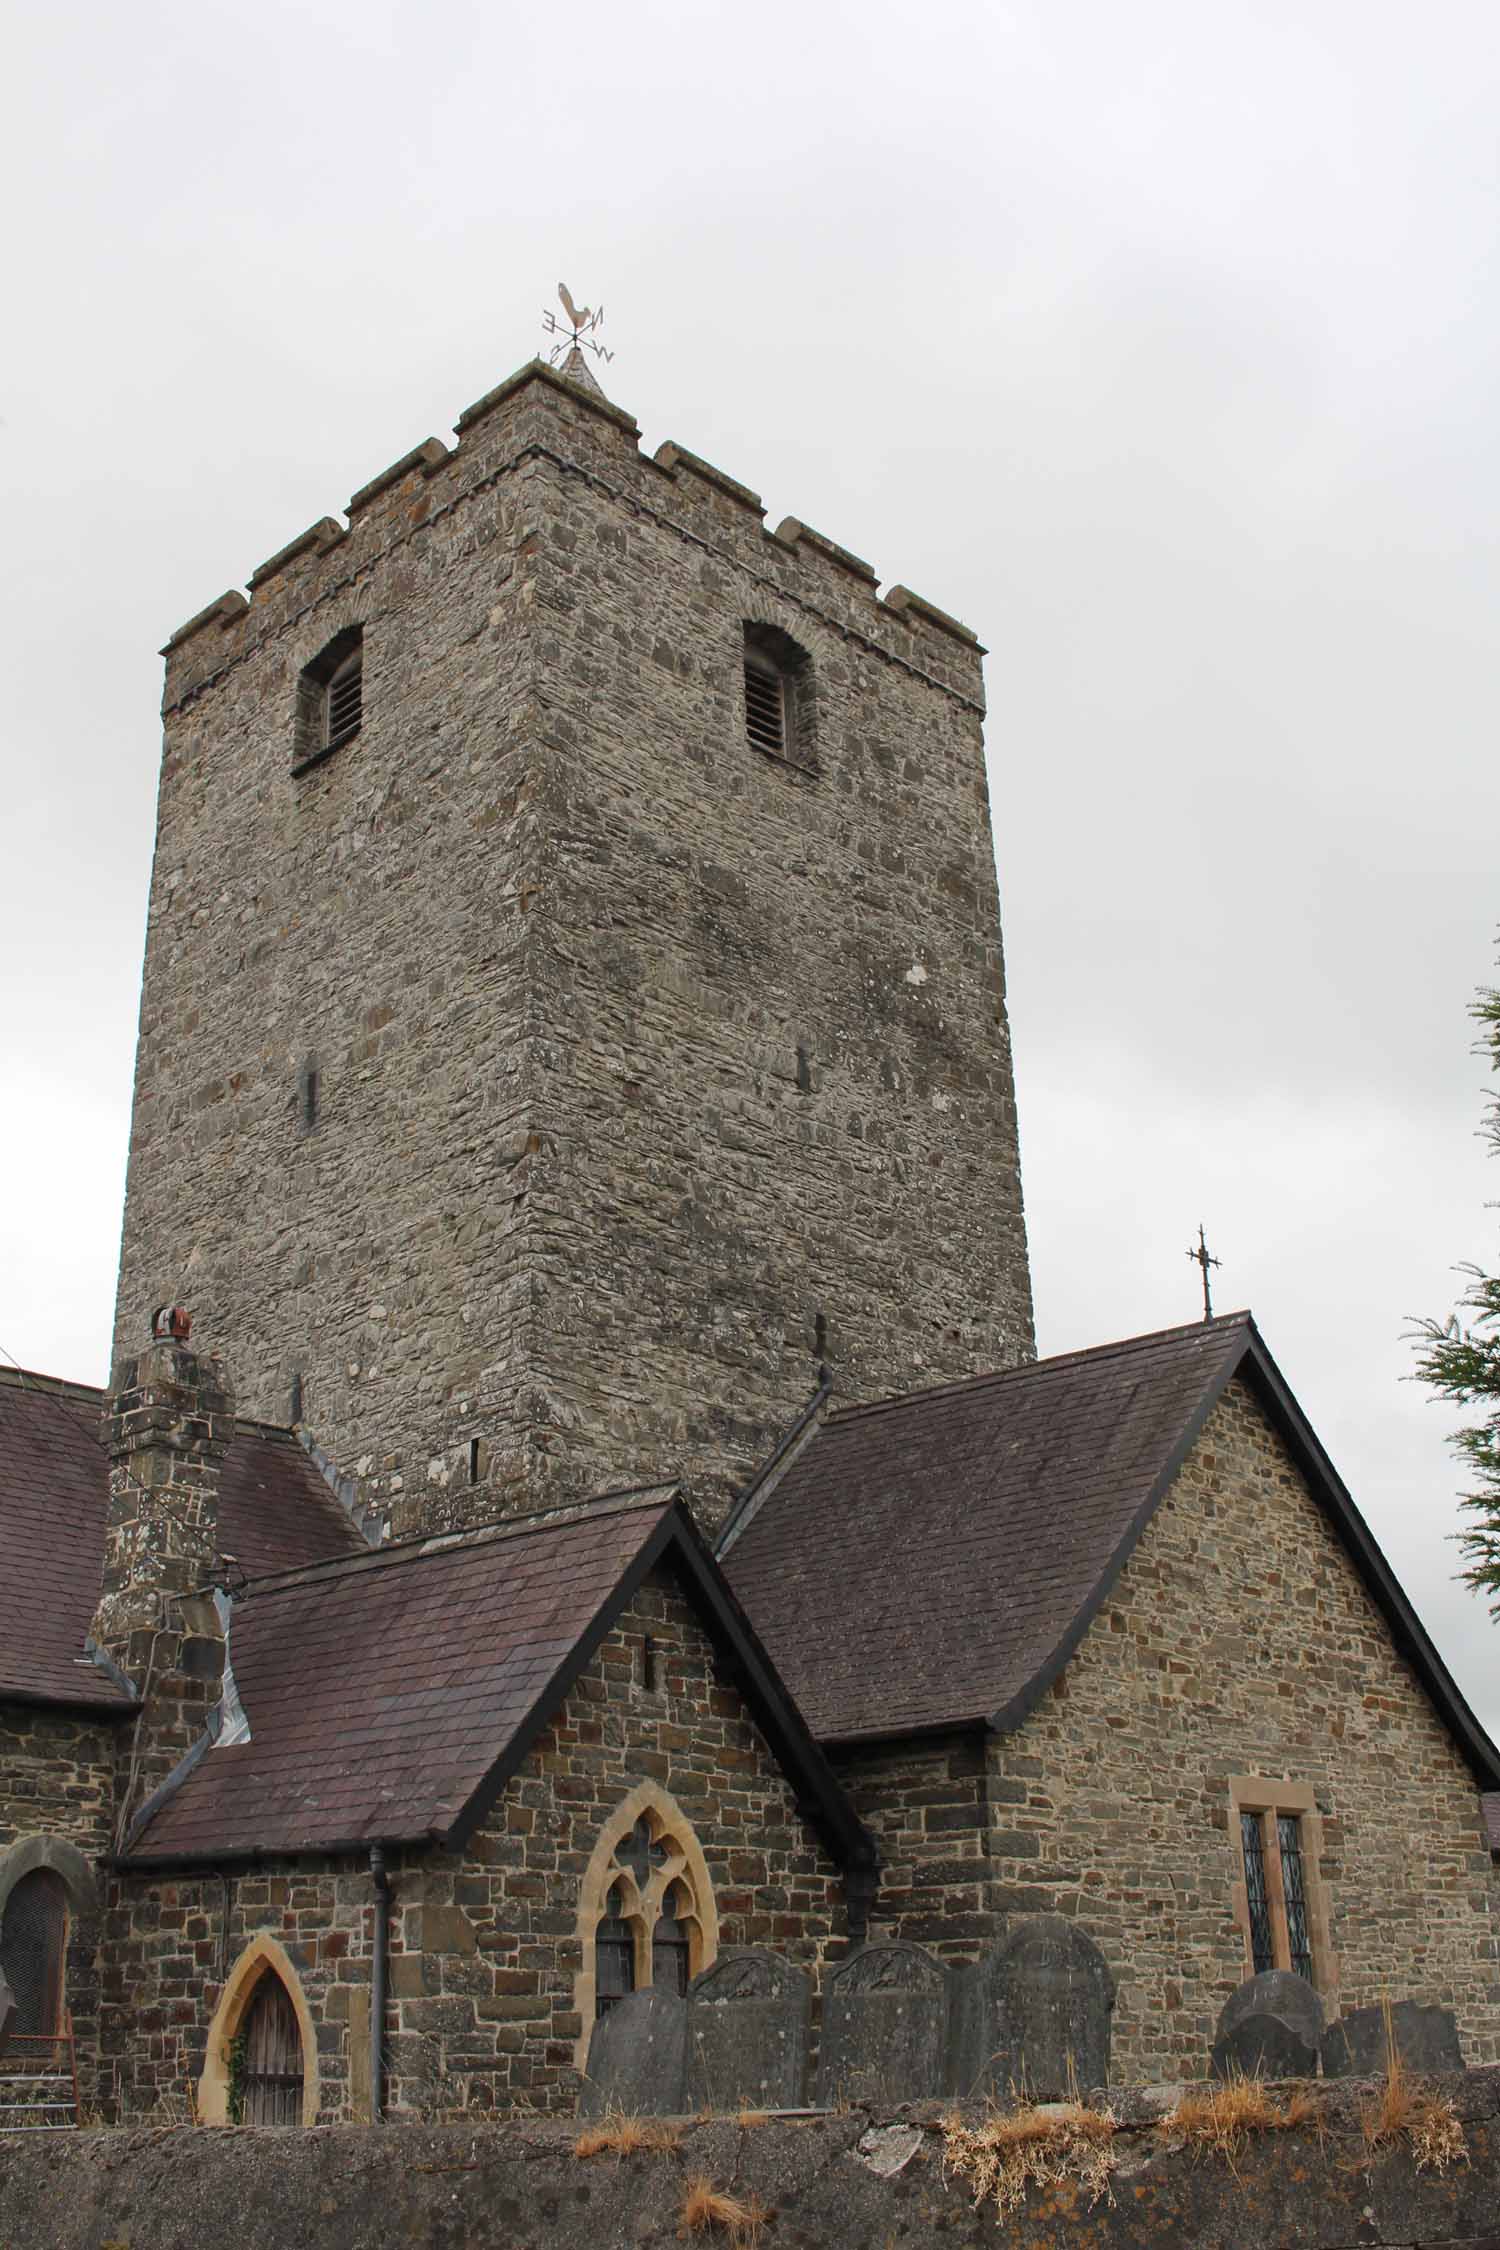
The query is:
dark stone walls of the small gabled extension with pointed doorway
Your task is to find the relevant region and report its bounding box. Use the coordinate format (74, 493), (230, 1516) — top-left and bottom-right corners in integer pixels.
(103, 1577), (843, 2122)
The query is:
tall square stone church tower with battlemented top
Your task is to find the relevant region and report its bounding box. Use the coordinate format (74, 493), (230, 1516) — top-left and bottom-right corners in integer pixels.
(117, 356), (1032, 1535)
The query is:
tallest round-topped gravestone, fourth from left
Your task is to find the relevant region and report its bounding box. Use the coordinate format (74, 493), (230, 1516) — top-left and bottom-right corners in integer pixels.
(954, 1915), (1115, 2102)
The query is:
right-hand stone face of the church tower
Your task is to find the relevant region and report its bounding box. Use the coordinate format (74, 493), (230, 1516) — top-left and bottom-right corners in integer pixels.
(517, 394), (1032, 1519)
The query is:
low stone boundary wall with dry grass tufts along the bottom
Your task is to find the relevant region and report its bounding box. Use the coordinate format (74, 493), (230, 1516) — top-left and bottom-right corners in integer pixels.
(0, 2070), (1500, 2250)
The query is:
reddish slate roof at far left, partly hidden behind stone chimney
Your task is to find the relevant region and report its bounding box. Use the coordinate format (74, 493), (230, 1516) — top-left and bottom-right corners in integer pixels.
(0, 1368), (367, 1712)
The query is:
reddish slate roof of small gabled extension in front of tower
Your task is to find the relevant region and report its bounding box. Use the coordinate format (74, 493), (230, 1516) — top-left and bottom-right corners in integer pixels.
(128, 1487), (873, 1865)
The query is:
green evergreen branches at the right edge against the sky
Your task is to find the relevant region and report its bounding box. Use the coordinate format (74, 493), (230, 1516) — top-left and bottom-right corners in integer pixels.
(1415, 986), (1500, 1622)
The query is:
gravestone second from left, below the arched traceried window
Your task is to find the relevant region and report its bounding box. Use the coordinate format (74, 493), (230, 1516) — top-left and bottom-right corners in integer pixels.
(688, 1946), (812, 2111)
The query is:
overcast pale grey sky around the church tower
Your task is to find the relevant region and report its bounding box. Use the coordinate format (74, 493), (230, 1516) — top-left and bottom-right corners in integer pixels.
(0, 0), (1500, 1730)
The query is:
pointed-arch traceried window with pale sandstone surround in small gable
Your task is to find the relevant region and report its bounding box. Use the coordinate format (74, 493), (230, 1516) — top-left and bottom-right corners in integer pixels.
(573, 1782), (720, 2070)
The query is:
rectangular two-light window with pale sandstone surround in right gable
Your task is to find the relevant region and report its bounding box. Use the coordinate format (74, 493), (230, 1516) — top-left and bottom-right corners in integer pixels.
(1230, 1773), (1338, 2003)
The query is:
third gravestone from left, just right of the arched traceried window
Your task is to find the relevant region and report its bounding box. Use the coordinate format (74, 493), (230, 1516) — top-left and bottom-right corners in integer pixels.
(819, 1942), (951, 2108)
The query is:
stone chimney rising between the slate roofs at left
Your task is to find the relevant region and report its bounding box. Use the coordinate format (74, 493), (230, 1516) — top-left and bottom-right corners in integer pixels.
(90, 1305), (234, 1787)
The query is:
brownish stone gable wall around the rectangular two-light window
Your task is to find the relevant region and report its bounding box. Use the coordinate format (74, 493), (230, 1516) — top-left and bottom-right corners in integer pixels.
(990, 1384), (1500, 2081)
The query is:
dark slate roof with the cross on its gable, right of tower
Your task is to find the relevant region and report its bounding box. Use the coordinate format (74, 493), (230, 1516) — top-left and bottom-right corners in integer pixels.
(720, 1312), (1500, 1787)
